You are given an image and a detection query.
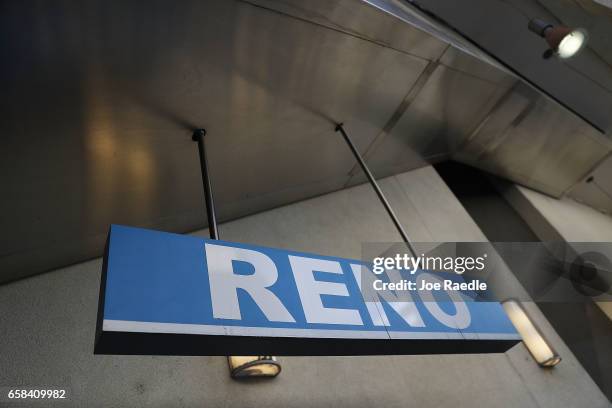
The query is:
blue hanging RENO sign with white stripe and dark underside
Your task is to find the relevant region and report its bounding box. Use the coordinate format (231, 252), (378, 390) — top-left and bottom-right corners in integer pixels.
(96, 225), (519, 355)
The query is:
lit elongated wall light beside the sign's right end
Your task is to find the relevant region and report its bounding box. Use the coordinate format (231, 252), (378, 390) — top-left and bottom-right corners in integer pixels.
(502, 299), (561, 367)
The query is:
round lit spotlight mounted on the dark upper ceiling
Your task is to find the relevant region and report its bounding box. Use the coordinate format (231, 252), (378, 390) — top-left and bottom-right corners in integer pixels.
(528, 18), (588, 59)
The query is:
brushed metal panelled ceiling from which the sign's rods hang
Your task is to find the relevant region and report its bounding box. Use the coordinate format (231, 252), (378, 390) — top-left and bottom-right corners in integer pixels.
(0, 0), (612, 282)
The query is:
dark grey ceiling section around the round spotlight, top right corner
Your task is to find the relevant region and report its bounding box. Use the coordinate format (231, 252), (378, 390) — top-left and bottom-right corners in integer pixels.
(410, 0), (612, 133)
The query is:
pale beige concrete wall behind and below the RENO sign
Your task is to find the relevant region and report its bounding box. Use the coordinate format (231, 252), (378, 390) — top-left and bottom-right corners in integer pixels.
(0, 167), (609, 408)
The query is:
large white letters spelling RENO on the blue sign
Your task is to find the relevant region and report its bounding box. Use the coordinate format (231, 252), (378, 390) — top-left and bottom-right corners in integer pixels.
(205, 243), (471, 329)
